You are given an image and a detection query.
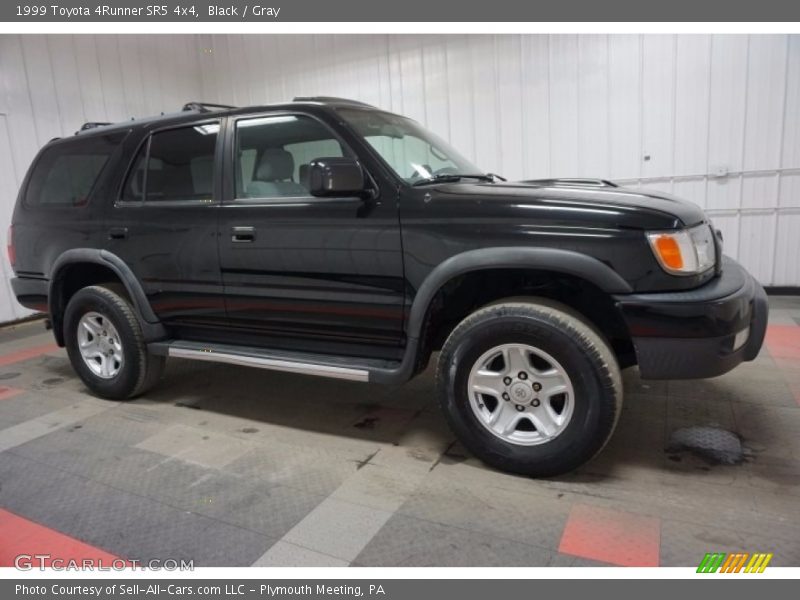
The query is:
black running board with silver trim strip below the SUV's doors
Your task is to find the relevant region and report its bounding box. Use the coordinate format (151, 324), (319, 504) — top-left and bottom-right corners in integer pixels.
(148, 341), (401, 382)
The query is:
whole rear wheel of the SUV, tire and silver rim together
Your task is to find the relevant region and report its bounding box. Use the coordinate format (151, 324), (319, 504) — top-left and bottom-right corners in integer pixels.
(64, 285), (166, 400)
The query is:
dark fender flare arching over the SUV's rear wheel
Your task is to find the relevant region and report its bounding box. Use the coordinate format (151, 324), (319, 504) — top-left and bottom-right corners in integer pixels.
(47, 248), (166, 344)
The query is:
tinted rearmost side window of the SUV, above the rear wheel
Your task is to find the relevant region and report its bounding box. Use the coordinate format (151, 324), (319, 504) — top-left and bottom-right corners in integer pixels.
(25, 132), (127, 208)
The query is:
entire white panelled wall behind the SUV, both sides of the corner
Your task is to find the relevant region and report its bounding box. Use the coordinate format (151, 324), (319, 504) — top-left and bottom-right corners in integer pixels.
(0, 35), (800, 321)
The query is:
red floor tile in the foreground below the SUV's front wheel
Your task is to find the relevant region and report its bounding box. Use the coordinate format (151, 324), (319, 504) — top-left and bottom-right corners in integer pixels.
(558, 504), (661, 567)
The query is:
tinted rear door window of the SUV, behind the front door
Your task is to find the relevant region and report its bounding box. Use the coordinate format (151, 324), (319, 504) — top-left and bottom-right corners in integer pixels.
(122, 123), (219, 202)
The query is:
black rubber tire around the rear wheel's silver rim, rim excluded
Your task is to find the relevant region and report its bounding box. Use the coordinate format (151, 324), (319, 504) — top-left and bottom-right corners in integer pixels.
(64, 285), (166, 400)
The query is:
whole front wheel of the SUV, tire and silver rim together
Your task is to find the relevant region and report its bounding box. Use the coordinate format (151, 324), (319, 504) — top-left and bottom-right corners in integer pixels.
(437, 301), (622, 477)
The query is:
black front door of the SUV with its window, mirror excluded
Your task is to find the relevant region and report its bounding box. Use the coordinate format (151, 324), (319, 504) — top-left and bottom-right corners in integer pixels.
(219, 113), (404, 358)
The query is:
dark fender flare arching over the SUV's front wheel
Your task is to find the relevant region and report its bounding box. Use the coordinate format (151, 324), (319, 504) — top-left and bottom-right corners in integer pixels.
(407, 246), (632, 340)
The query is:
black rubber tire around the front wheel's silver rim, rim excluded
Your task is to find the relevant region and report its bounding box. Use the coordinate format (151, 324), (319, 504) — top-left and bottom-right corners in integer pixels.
(436, 300), (622, 477)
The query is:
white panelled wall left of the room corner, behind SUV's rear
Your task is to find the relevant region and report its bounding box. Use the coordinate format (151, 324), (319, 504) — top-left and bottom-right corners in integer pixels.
(0, 35), (201, 322)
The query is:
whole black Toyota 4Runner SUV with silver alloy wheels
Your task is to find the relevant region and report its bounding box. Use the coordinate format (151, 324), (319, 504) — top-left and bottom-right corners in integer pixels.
(9, 98), (768, 476)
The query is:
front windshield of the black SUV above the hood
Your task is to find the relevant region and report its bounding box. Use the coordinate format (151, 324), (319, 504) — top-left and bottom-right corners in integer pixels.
(339, 108), (483, 184)
